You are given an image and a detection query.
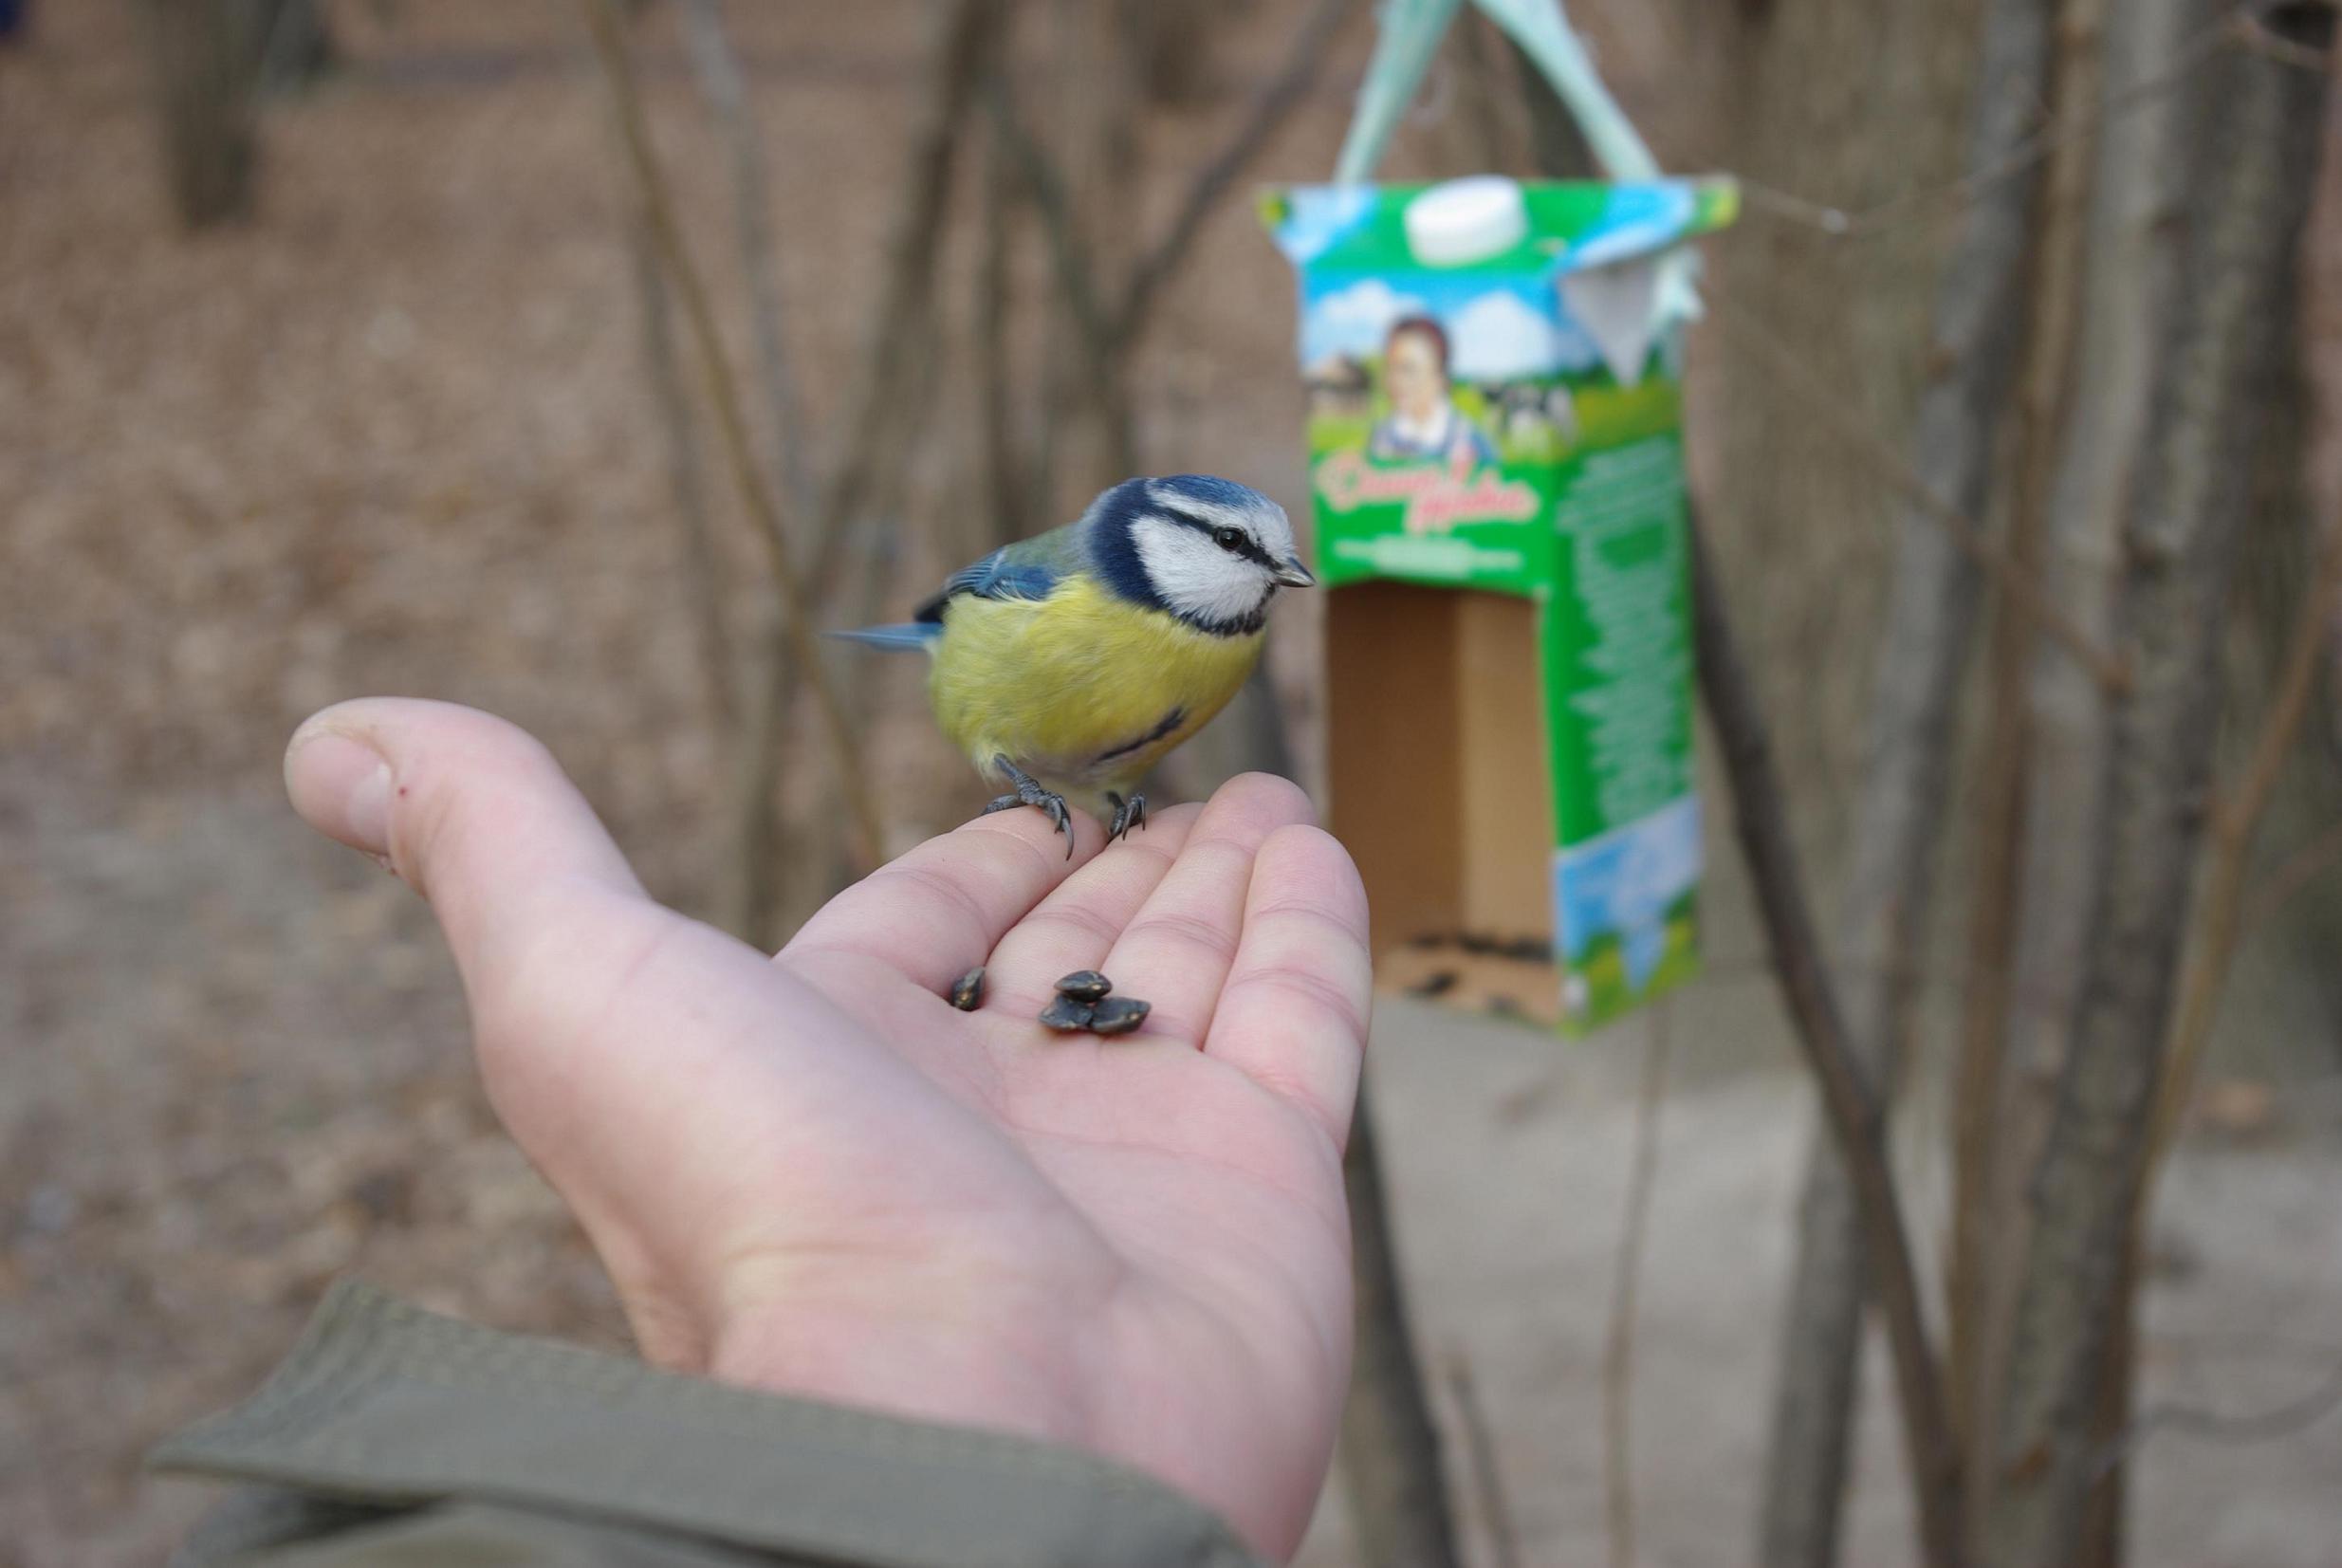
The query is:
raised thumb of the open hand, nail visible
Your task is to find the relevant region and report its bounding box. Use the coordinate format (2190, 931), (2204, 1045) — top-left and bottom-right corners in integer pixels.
(286, 697), (649, 987)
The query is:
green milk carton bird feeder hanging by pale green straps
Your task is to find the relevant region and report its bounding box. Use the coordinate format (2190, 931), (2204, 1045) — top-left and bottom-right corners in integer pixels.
(1263, 0), (1738, 1034)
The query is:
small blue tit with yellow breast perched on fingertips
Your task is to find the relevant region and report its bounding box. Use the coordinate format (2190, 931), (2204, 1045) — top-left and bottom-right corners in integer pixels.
(839, 472), (1317, 857)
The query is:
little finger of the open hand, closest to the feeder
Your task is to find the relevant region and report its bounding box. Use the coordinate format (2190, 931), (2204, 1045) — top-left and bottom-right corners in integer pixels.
(1204, 826), (1374, 1147)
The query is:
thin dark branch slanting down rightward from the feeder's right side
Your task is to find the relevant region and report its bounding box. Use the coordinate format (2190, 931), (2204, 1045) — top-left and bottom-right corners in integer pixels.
(1691, 510), (1967, 1568)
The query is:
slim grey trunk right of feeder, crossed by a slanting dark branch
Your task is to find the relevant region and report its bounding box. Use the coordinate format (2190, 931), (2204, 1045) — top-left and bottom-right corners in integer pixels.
(1761, 0), (2054, 1568)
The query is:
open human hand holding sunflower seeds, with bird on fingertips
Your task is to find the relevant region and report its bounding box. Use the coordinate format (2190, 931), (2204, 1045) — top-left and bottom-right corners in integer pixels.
(286, 697), (1370, 1557)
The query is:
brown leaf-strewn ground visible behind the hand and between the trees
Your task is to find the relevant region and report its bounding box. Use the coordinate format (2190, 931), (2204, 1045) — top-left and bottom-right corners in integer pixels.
(0, 0), (2342, 1568)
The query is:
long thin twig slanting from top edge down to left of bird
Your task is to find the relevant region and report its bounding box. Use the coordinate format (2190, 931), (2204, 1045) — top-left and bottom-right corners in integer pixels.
(579, 0), (885, 863)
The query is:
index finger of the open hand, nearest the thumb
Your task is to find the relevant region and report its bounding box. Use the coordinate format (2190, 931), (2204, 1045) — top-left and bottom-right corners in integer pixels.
(780, 810), (1105, 992)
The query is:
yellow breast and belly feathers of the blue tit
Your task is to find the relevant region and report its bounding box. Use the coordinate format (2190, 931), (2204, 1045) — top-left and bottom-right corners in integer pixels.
(928, 578), (1263, 802)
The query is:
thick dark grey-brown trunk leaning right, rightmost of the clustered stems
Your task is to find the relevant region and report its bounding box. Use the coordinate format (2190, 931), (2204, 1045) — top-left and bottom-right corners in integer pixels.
(1986, 15), (2333, 1568)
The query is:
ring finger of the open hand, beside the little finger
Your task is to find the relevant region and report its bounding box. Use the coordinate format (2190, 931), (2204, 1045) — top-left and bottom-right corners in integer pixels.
(1103, 772), (1312, 1043)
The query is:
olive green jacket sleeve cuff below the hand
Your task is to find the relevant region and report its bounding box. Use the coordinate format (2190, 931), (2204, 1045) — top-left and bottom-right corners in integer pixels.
(152, 1282), (1258, 1568)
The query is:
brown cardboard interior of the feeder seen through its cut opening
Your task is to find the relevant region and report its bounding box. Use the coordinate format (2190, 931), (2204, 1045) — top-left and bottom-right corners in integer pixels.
(1325, 582), (1562, 1023)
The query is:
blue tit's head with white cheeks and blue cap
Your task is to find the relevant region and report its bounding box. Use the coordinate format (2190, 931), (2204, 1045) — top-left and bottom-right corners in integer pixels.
(1092, 472), (1317, 632)
